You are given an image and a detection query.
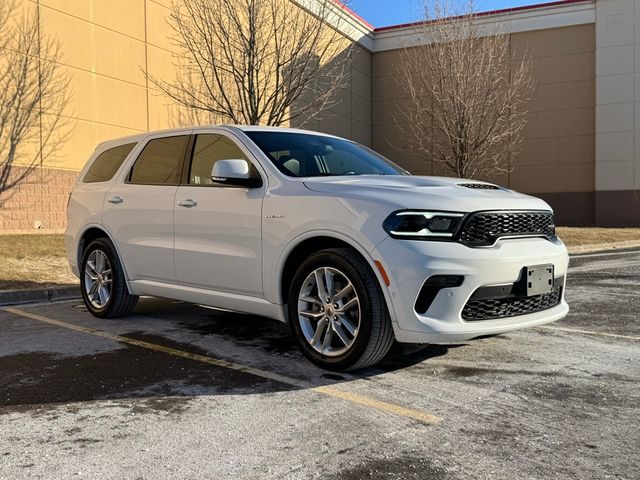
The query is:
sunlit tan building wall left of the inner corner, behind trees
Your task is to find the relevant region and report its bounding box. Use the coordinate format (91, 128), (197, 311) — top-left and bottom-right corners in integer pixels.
(0, 0), (371, 231)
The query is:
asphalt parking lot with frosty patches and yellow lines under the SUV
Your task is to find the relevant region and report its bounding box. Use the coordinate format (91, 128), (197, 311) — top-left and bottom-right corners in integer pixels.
(0, 250), (640, 480)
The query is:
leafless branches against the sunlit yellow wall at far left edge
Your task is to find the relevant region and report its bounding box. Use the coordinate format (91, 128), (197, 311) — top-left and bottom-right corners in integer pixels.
(0, 0), (70, 205)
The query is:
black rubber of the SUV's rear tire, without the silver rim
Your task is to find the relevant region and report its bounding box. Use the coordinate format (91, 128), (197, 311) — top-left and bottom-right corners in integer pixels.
(80, 238), (138, 318)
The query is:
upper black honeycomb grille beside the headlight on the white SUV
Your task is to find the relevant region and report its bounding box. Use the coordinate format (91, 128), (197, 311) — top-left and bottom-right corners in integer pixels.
(458, 211), (556, 247)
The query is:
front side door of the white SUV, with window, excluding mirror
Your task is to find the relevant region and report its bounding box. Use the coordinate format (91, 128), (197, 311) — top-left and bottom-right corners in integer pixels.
(174, 130), (266, 296)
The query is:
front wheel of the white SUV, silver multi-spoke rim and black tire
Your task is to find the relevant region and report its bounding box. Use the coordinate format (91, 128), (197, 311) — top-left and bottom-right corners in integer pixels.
(288, 248), (394, 370)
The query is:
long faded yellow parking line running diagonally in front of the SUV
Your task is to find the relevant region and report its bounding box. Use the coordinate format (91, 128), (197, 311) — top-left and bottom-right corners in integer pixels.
(2, 307), (441, 424)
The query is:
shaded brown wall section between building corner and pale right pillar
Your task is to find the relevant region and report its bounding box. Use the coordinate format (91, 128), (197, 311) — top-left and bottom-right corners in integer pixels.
(372, 24), (595, 228)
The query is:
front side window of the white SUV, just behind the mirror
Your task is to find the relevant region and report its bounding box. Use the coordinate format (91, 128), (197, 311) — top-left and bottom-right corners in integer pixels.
(189, 134), (260, 186)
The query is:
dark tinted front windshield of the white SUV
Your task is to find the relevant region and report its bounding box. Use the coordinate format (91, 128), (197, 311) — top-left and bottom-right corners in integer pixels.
(245, 131), (409, 177)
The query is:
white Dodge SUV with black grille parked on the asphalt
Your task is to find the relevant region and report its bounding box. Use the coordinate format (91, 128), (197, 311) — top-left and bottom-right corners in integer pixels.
(66, 126), (569, 370)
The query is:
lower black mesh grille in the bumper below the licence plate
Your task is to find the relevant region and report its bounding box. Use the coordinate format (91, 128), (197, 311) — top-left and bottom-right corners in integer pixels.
(462, 287), (562, 322)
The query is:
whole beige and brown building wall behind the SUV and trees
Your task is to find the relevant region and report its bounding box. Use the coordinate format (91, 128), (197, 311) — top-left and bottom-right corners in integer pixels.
(5, 0), (640, 231)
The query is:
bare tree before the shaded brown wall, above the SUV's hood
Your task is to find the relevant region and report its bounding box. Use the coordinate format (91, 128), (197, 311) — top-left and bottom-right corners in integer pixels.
(397, 0), (534, 178)
